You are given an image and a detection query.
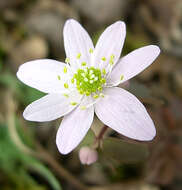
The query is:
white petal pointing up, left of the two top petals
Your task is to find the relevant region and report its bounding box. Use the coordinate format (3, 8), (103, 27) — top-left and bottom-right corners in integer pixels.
(63, 19), (94, 66)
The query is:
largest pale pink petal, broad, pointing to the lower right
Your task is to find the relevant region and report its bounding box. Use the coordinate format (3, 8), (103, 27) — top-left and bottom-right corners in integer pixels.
(95, 87), (156, 141)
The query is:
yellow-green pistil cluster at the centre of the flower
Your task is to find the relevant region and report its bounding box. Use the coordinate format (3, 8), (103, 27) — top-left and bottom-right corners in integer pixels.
(71, 67), (106, 96)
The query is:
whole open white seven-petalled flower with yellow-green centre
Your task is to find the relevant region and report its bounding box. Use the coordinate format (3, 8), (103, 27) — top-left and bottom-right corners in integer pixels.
(17, 19), (160, 154)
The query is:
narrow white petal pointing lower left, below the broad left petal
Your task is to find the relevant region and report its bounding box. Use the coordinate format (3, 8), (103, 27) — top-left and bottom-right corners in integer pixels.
(23, 92), (81, 122)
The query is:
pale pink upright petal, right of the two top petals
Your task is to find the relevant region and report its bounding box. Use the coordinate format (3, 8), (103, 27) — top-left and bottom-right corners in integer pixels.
(93, 21), (126, 68)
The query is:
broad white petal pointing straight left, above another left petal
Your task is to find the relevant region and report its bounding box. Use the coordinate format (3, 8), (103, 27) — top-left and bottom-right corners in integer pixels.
(17, 59), (70, 93)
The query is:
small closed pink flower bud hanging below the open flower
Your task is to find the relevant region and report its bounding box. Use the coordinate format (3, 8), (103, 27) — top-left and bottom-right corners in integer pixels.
(79, 146), (98, 165)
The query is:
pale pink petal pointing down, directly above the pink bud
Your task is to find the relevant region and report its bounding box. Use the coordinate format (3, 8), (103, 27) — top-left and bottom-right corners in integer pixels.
(56, 106), (94, 154)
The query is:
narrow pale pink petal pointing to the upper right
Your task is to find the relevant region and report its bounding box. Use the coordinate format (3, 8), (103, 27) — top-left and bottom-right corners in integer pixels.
(108, 45), (160, 85)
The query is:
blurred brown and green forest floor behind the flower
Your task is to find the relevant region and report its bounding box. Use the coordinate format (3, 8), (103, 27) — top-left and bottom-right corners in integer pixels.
(0, 0), (182, 190)
